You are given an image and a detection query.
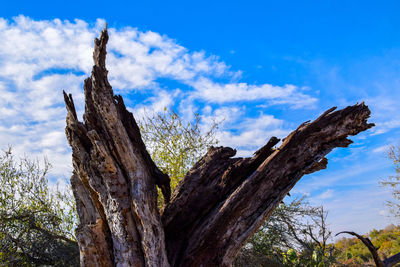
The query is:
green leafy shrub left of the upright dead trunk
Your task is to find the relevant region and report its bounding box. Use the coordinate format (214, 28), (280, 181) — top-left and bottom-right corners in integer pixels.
(0, 149), (79, 266)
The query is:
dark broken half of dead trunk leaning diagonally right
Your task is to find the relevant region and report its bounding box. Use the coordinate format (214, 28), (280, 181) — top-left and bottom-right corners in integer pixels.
(163, 103), (373, 266)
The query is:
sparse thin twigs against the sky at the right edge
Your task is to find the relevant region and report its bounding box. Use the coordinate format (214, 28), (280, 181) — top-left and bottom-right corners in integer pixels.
(381, 146), (400, 218)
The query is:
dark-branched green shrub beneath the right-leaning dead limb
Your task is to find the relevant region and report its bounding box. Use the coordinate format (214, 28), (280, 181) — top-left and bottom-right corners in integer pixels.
(235, 198), (335, 267)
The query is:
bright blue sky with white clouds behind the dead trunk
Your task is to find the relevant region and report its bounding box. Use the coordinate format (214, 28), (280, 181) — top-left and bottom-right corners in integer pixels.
(0, 1), (400, 237)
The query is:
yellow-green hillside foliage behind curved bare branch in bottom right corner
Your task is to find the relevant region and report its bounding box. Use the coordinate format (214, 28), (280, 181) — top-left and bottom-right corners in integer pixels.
(335, 225), (400, 266)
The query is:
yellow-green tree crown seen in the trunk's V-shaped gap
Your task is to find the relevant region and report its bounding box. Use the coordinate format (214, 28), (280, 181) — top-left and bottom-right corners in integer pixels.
(138, 108), (218, 203)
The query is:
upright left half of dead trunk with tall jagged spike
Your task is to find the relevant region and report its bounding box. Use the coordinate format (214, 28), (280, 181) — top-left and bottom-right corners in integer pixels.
(64, 26), (169, 266)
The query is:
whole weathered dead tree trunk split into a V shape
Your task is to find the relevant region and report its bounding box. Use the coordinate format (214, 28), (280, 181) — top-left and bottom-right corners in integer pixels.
(64, 29), (373, 266)
